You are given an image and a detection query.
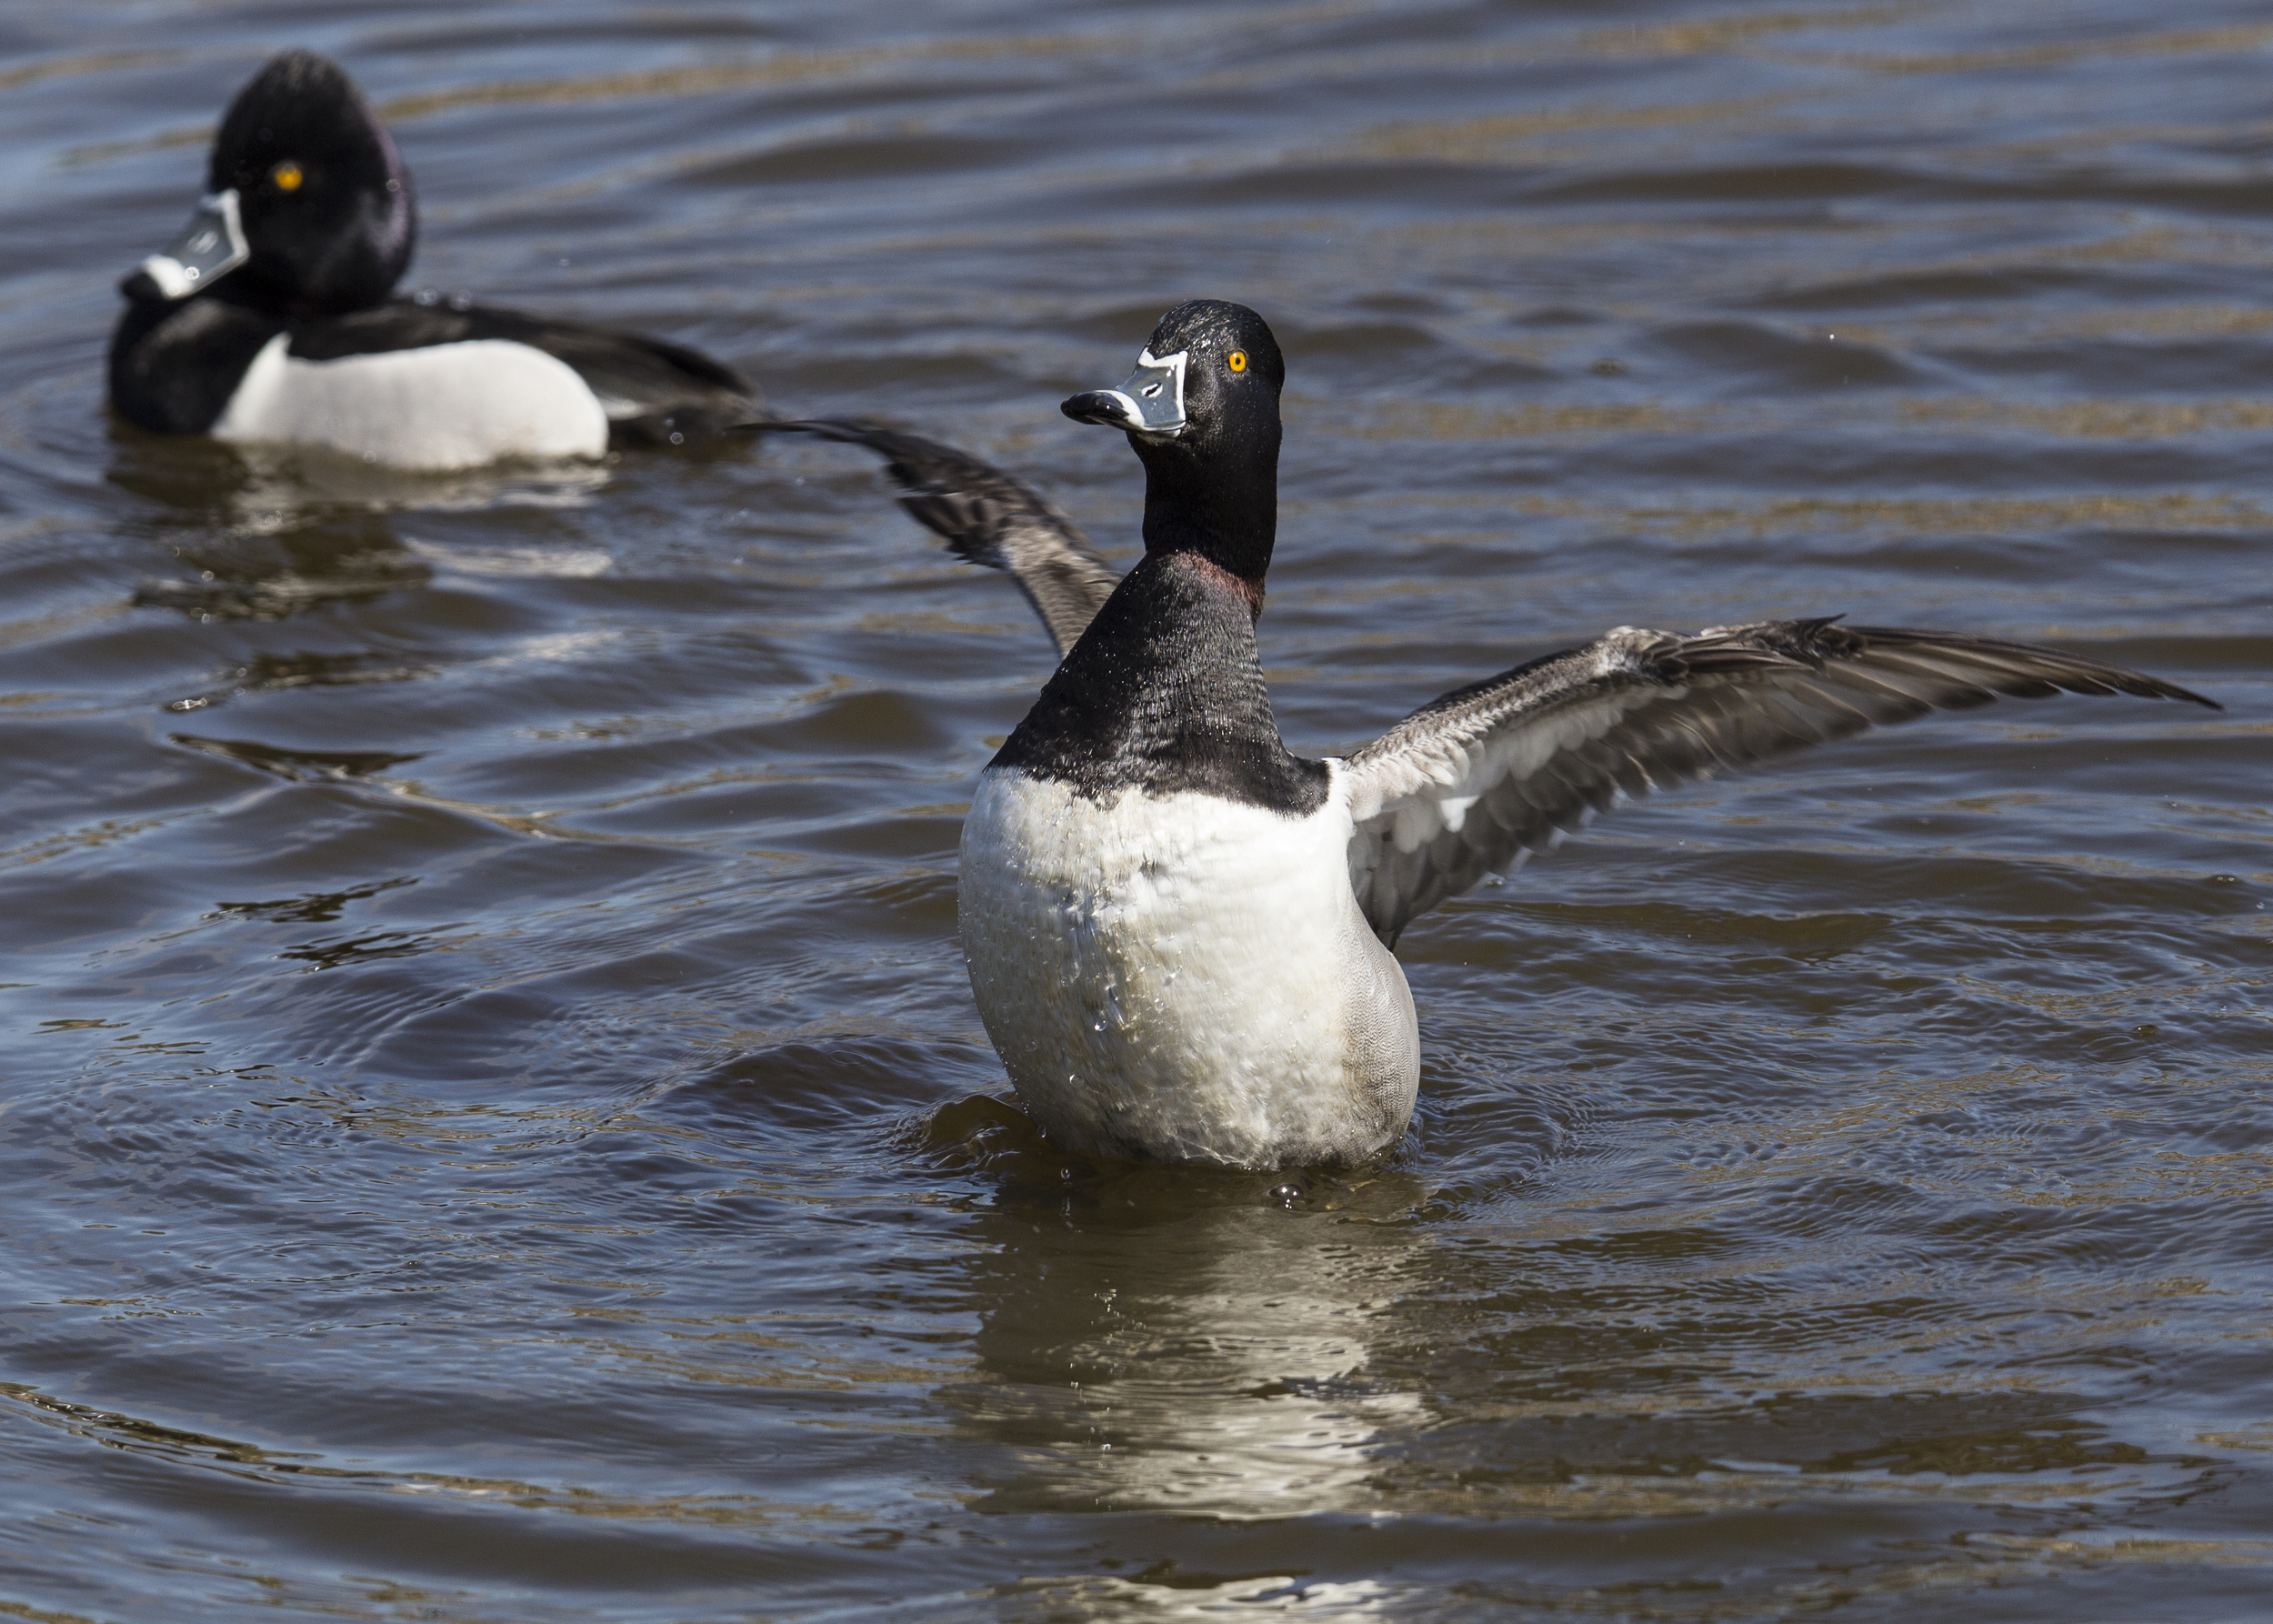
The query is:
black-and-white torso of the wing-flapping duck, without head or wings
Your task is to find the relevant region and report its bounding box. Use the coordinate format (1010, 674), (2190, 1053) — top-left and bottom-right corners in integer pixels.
(962, 553), (1421, 1165)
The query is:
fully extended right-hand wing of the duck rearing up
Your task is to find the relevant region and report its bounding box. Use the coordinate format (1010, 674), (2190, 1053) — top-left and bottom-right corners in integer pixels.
(1346, 618), (2218, 944)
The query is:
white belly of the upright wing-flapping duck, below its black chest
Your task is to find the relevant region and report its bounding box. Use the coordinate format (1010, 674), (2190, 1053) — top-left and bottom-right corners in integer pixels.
(962, 767), (1418, 1167)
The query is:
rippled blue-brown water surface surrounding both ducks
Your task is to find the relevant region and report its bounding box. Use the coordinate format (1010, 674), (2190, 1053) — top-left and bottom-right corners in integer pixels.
(0, 0), (2273, 1624)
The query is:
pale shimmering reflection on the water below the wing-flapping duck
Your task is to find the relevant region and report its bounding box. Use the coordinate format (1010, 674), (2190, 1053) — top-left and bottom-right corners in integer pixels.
(927, 1098), (1426, 1517)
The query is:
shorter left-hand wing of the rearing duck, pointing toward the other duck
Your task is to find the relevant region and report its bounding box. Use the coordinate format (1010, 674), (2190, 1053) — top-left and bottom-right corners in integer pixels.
(744, 418), (1121, 657)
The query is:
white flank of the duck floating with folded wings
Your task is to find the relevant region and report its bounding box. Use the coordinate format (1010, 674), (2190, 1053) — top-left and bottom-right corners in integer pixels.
(214, 332), (607, 468)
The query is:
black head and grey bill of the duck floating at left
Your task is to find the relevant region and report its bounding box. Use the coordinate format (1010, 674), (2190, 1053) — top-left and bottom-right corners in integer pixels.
(123, 50), (418, 316)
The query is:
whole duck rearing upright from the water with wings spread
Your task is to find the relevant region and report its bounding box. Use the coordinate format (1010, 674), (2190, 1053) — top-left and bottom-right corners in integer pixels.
(755, 300), (2217, 1167)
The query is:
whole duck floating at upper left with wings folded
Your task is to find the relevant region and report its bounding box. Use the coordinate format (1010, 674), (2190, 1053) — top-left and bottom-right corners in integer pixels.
(109, 50), (757, 468)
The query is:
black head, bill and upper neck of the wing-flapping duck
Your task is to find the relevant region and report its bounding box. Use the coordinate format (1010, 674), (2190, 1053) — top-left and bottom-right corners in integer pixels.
(1062, 298), (1287, 582)
